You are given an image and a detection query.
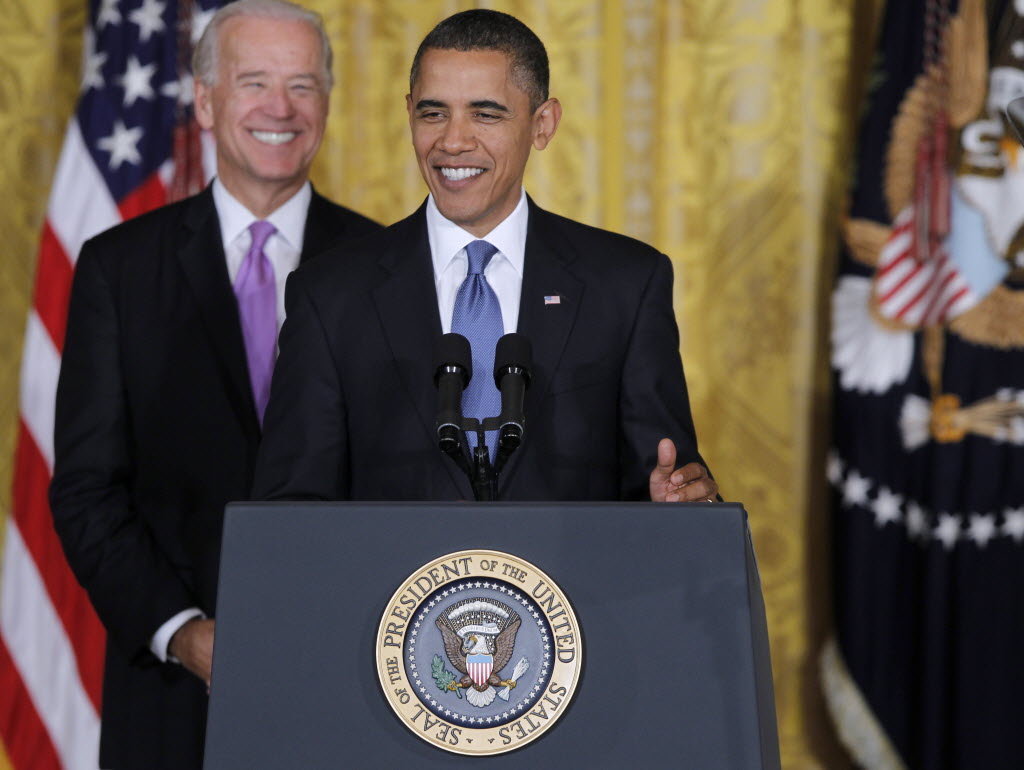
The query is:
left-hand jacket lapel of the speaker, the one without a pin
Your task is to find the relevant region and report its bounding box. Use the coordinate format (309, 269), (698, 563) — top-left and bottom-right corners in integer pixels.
(373, 206), (472, 498)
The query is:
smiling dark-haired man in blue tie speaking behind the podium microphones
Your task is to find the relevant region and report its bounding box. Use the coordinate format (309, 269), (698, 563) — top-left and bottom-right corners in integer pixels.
(254, 10), (718, 502)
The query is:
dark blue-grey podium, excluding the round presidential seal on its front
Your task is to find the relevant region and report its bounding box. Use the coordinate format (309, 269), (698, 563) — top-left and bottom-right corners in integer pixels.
(205, 503), (780, 770)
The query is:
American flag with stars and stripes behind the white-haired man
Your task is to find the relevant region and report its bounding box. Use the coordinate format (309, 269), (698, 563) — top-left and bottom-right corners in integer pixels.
(0, 0), (218, 770)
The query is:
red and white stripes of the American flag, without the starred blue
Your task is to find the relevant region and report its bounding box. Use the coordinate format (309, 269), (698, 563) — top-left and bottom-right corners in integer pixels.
(0, 120), (167, 770)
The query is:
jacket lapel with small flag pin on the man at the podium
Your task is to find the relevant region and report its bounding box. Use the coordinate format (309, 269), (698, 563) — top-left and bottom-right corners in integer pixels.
(501, 200), (585, 490)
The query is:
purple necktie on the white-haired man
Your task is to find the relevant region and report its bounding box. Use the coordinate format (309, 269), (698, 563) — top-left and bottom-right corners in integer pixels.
(234, 220), (278, 425)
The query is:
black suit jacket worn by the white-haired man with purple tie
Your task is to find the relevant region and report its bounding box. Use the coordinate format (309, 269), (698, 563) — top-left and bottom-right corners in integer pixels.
(50, 188), (379, 770)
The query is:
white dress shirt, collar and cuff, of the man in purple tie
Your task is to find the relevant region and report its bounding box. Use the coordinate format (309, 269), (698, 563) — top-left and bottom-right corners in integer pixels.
(150, 179), (309, 662)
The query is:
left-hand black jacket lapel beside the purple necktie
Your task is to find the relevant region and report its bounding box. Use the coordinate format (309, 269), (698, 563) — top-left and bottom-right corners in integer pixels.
(177, 187), (260, 441)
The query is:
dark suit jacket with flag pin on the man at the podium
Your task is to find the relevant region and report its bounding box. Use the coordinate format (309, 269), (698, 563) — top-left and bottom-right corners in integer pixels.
(253, 202), (702, 501)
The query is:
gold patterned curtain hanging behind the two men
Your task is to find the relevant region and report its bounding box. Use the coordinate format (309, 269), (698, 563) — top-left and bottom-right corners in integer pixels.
(0, 0), (881, 768)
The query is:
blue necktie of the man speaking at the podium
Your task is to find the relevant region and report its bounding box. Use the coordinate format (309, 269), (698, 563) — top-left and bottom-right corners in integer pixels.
(452, 241), (505, 460)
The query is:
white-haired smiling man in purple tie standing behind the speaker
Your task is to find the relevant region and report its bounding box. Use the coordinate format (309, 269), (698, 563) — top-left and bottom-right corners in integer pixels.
(50, 0), (378, 770)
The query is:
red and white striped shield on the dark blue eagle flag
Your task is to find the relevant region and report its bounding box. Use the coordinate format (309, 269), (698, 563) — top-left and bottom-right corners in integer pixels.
(874, 206), (978, 328)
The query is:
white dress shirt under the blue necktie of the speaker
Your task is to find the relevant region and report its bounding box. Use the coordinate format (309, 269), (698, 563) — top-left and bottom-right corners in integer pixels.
(427, 191), (529, 334)
